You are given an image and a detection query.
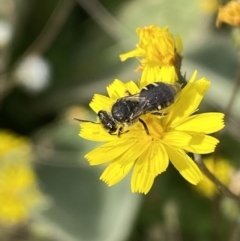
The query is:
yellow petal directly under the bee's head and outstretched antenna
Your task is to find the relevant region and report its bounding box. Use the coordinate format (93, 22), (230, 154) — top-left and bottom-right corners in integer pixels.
(79, 122), (118, 141)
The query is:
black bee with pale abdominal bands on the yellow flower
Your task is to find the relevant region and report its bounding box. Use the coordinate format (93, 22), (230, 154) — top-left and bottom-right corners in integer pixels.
(75, 82), (181, 136)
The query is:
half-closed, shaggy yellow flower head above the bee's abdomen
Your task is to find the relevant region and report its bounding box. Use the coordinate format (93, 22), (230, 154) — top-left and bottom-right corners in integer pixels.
(120, 25), (183, 83)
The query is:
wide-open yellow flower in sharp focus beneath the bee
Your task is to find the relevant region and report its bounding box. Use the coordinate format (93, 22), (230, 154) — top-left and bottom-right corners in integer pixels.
(80, 72), (224, 194)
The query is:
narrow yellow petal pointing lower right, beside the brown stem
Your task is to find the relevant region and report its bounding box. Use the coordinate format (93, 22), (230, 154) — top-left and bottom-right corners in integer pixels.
(165, 145), (203, 185)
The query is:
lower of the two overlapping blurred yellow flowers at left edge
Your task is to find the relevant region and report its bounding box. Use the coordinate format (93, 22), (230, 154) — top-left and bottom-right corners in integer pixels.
(0, 162), (42, 224)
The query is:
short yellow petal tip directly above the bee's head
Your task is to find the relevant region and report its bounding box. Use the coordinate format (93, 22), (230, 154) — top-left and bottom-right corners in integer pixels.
(89, 94), (114, 113)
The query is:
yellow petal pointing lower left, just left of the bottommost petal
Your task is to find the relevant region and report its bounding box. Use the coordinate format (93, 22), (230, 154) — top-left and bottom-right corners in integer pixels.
(100, 159), (134, 186)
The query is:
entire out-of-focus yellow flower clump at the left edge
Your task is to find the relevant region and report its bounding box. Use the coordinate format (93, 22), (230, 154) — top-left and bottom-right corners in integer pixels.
(0, 130), (44, 225)
